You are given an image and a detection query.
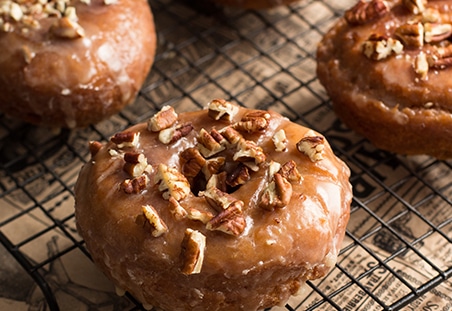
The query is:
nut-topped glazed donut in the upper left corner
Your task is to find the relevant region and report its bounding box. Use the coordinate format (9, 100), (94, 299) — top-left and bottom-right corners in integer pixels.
(0, 0), (156, 128)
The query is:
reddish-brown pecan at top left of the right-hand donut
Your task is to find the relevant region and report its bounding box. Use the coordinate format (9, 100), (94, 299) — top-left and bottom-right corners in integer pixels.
(344, 0), (389, 25)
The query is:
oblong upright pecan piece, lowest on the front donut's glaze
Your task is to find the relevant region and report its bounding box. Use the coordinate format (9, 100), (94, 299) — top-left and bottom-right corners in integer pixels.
(180, 228), (206, 275)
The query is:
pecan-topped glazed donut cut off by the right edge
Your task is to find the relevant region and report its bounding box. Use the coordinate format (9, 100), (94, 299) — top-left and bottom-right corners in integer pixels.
(317, 0), (452, 159)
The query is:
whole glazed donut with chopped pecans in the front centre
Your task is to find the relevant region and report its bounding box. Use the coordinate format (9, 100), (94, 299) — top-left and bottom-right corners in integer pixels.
(75, 99), (352, 311)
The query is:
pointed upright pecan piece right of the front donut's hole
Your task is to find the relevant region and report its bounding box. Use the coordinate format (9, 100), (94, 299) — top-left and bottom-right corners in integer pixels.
(259, 173), (292, 211)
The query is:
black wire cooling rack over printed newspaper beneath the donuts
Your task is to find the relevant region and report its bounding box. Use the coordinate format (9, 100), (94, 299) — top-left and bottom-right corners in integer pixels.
(0, 0), (452, 311)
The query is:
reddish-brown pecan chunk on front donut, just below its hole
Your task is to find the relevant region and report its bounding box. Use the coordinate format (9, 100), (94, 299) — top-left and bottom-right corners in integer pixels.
(206, 200), (246, 236)
